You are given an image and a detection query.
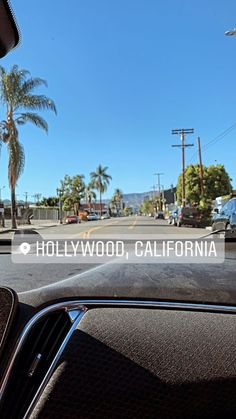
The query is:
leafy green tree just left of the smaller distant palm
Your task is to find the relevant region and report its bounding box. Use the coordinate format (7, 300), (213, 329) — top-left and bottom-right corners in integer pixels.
(60, 175), (85, 215)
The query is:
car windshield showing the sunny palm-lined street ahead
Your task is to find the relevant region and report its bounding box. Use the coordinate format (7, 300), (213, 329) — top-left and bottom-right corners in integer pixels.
(0, 0), (236, 302)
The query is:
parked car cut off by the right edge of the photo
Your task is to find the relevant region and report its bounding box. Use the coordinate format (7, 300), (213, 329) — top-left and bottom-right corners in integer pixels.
(212, 198), (236, 238)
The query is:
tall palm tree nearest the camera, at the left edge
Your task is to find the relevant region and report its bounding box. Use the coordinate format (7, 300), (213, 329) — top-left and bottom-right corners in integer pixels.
(0, 65), (56, 228)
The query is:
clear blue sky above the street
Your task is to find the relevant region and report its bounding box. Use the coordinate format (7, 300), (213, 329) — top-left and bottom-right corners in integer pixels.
(0, 0), (236, 199)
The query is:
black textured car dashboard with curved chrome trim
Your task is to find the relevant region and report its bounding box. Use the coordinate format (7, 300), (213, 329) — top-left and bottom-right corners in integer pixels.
(0, 288), (236, 419)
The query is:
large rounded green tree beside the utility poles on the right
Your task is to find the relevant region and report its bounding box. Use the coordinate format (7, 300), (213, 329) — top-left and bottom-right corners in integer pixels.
(177, 164), (232, 206)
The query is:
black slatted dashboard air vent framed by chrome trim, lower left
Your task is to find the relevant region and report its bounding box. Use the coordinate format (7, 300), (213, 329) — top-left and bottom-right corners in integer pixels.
(1, 310), (72, 419)
